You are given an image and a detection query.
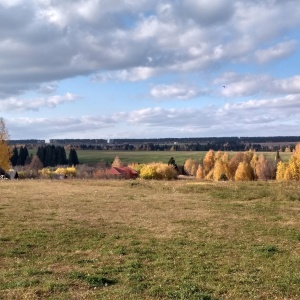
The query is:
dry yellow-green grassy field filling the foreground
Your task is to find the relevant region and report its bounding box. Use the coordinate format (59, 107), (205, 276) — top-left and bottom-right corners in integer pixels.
(0, 180), (300, 300)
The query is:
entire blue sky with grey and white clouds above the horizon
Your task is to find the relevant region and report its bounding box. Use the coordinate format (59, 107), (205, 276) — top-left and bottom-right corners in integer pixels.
(0, 0), (300, 140)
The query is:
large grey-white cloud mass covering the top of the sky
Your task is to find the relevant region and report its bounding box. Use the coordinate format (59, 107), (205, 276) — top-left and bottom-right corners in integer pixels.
(0, 0), (300, 95)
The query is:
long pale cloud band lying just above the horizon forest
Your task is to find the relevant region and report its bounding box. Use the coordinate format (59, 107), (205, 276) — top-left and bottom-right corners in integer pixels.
(5, 94), (300, 139)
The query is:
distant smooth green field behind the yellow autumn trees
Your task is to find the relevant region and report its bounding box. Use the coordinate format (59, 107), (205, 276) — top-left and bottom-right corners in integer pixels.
(71, 150), (291, 165)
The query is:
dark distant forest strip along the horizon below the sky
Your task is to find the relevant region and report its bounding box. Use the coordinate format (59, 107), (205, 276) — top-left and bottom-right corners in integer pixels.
(9, 136), (300, 151)
